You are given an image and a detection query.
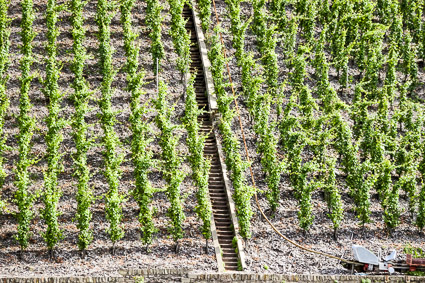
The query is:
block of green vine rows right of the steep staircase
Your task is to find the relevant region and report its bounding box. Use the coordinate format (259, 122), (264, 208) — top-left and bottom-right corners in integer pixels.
(199, 0), (425, 240)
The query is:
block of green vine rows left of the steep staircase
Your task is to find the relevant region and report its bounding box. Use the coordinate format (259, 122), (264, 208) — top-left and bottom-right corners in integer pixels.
(0, 0), (212, 257)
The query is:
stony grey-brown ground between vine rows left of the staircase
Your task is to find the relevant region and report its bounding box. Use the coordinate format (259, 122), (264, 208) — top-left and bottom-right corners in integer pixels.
(0, 0), (217, 276)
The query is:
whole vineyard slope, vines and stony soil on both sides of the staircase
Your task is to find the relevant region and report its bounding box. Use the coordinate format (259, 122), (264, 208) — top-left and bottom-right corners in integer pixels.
(0, 0), (425, 275)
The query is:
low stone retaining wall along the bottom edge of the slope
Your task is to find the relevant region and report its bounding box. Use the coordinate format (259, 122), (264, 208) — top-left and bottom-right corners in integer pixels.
(0, 269), (425, 283)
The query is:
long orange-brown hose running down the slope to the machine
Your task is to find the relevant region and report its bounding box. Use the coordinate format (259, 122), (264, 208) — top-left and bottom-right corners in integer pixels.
(207, 0), (357, 264)
